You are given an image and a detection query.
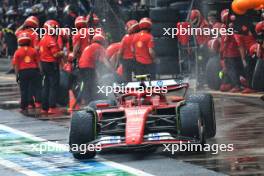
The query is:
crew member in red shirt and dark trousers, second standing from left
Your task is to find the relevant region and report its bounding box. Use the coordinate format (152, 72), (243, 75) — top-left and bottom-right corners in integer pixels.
(39, 20), (64, 114)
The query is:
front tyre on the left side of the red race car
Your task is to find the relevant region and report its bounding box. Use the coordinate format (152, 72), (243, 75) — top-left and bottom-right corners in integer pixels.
(69, 111), (96, 159)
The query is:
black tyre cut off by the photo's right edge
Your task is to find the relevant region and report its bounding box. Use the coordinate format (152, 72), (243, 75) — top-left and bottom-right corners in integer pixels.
(252, 59), (264, 91)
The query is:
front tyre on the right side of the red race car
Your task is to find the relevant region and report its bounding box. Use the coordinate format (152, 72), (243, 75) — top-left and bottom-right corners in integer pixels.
(180, 103), (205, 144)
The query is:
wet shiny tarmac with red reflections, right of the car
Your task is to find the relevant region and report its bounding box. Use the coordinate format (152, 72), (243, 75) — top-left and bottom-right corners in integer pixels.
(163, 96), (264, 176)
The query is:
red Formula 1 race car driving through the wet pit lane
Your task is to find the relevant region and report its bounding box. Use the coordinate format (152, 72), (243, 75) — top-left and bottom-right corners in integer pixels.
(69, 75), (216, 159)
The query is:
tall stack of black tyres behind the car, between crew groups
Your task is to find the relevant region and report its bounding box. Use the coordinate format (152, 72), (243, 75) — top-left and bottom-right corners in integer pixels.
(150, 0), (190, 76)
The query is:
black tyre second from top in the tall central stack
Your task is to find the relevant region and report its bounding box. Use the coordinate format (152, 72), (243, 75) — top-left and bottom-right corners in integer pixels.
(150, 7), (179, 22)
